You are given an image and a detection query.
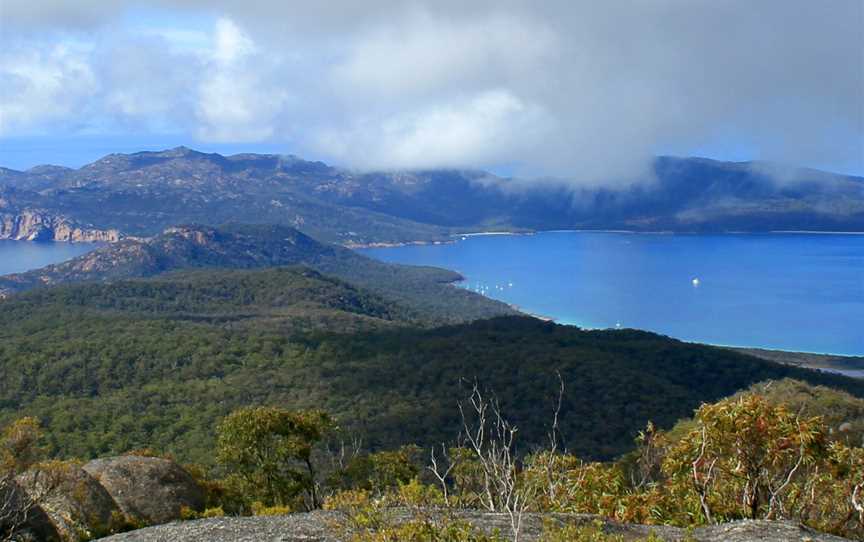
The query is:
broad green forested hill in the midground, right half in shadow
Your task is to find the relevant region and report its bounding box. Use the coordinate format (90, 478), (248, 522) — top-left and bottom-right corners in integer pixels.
(0, 268), (864, 464)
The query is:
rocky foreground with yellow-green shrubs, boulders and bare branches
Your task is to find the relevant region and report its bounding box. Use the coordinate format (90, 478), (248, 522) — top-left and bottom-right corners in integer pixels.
(6, 380), (864, 542)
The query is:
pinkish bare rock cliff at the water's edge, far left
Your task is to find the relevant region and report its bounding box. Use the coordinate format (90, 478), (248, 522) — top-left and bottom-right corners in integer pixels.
(0, 210), (120, 243)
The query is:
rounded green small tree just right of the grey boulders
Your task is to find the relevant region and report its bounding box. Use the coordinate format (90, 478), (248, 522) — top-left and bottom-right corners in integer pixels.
(217, 407), (335, 509)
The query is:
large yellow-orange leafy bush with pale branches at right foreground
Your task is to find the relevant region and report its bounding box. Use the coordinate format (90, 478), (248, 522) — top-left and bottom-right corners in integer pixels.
(663, 395), (826, 522)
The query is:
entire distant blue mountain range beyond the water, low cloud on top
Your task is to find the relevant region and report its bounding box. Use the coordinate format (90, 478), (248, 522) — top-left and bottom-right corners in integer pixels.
(0, 147), (864, 245)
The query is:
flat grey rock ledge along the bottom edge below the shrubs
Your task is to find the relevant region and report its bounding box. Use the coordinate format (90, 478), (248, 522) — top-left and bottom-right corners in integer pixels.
(102, 511), (846, 542)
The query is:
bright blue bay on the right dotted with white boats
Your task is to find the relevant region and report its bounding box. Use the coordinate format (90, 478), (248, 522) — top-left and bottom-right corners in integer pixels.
(361, 232), (864, 355)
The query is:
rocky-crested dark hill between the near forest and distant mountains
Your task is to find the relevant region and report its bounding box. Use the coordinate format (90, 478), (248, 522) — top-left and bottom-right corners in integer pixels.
(0, 225), (515, 323)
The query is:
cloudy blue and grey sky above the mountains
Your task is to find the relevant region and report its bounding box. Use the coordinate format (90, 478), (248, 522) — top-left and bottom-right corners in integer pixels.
(0, 0), (864, 183)
